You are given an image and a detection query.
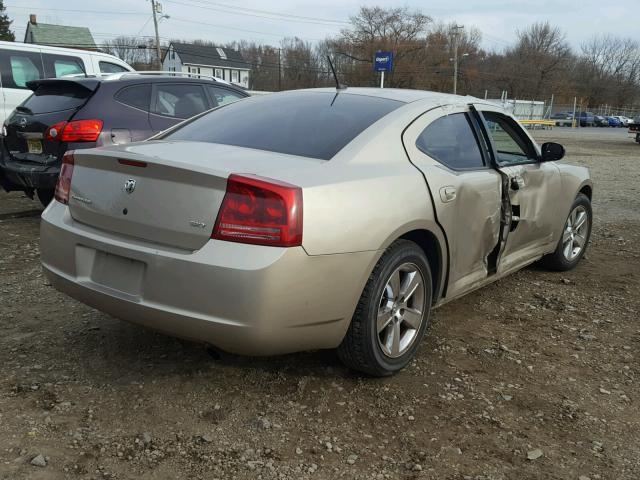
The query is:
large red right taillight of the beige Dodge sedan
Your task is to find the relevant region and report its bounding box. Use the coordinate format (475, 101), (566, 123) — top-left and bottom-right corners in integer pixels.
(211, 174), (302, 247)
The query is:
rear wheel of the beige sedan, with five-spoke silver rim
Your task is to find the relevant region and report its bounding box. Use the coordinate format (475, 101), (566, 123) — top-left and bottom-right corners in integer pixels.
(338, 240), (432, 377)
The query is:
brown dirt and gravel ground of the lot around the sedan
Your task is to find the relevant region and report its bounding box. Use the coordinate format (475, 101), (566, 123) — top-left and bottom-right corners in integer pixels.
(0, 128), (640, 480)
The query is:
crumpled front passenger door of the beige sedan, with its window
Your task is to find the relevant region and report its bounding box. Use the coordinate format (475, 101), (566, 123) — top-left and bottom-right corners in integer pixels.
(479, 106), (561, 274)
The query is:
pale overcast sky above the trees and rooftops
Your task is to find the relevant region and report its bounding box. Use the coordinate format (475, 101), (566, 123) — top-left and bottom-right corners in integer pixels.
(4, 0), (640, 50)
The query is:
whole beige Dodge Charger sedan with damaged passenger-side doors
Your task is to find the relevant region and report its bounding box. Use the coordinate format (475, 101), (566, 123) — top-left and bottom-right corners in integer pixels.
(41, 88), (592, 376)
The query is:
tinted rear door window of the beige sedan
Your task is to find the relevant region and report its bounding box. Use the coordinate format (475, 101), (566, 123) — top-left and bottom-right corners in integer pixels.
(416, 113), (484, 170)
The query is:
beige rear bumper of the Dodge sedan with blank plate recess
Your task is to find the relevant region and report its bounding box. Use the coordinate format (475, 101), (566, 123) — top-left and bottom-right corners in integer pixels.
(40, 201), (379, 355)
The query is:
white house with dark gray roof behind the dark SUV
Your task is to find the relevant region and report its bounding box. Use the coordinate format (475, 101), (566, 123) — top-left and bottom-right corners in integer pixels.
(162, 42), (250, 88)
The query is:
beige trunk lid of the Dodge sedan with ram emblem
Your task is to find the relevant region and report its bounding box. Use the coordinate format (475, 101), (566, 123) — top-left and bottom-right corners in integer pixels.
(69, 141), (321, 250)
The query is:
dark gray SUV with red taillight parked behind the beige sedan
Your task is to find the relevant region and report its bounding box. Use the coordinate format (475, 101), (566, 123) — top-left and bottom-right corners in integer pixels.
(0, 74), (249, 205)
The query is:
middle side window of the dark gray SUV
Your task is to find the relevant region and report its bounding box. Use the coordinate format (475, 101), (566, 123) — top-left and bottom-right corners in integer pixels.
(153, 84), (209, 119)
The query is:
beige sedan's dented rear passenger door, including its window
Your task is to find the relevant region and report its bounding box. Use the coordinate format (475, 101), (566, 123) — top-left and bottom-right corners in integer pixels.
(402, 105), (502, 298)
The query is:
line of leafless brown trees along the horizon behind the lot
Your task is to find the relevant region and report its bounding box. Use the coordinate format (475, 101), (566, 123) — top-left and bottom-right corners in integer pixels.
(142, 7), (640, 107)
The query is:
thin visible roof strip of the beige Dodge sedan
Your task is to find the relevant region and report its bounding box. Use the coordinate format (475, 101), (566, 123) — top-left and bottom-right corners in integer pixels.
(296, 87), (482, 106)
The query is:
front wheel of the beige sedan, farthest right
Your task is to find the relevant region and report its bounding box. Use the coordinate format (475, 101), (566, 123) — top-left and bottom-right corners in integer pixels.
(542, 193), (593, 271)
